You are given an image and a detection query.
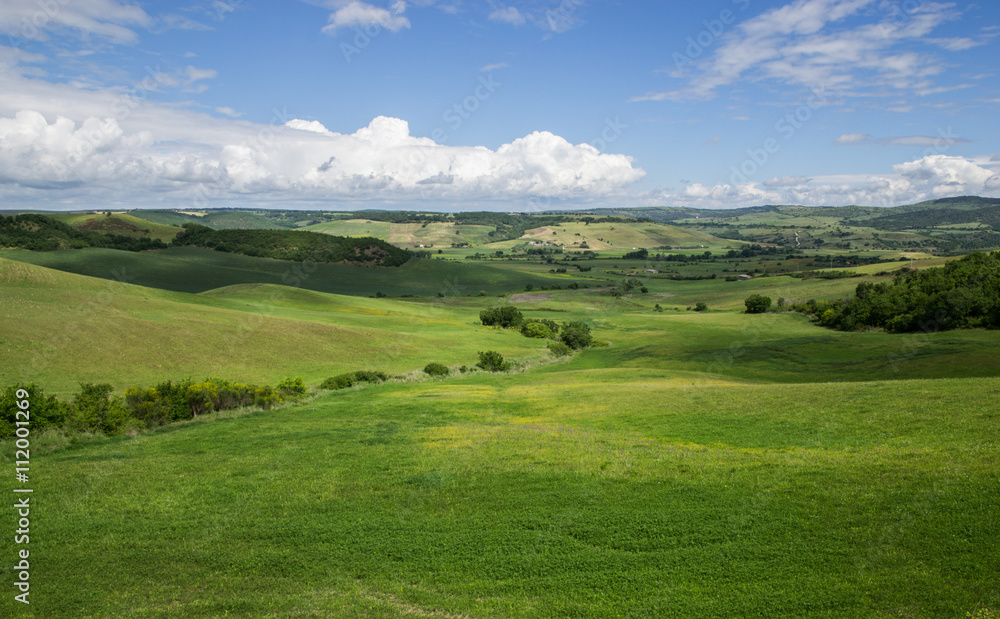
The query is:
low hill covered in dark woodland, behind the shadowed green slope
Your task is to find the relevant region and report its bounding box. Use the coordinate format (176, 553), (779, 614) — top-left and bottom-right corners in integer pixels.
(173, 223), (413, 267)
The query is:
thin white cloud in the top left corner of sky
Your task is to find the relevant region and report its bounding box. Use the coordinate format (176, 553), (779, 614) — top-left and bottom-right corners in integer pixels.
(0, 0), (153, 43)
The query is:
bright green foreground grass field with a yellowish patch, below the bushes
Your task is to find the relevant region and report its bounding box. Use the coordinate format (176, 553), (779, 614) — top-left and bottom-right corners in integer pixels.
(0, 368), (1000, 617)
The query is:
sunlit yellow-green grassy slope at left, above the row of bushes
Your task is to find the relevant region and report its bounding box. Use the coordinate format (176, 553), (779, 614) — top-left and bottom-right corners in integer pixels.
(0, 259), (542, 393)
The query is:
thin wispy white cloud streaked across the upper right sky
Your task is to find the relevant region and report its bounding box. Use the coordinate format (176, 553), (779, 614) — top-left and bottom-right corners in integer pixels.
(633, 0), (967, 101)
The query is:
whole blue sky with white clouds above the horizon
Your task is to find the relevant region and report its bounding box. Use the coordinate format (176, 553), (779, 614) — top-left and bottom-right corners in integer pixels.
(0, 0), (1000, 211)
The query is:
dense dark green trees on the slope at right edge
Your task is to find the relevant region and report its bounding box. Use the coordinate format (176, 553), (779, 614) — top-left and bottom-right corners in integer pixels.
(793, 252), (1000, 333)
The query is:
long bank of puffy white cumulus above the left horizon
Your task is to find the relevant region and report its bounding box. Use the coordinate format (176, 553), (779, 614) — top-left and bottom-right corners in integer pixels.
(0, 111), (645, 207)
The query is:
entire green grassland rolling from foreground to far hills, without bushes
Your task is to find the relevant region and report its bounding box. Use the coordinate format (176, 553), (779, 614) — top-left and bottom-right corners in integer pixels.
(0, 207), (1000, 619)
